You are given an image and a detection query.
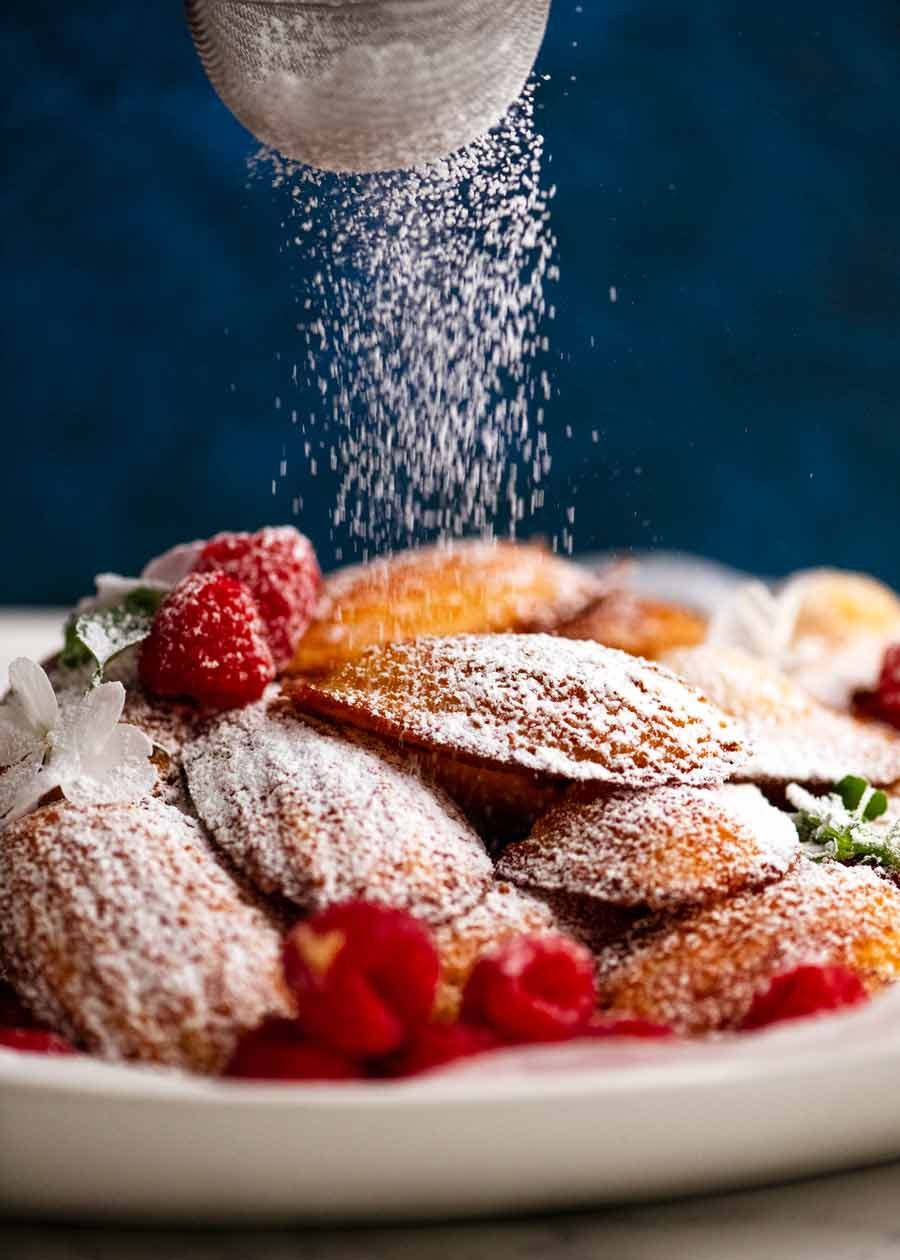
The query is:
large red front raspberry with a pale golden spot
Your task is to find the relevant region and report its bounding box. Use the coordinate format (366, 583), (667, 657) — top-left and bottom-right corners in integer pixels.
(284, 901), (440, 1058)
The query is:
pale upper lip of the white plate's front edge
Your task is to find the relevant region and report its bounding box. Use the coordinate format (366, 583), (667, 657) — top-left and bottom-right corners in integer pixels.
(7, 993), (900, 1110)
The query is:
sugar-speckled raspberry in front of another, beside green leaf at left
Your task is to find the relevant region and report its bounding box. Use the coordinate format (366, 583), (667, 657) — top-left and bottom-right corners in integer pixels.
(139, 573), (275, 708)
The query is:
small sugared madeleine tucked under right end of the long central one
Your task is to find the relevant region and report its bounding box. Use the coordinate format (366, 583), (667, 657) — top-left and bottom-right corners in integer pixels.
(497, 784), (799, 914)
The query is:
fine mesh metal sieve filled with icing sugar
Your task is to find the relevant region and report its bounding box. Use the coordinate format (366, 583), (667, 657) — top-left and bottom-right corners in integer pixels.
(185, 0), (550, 171)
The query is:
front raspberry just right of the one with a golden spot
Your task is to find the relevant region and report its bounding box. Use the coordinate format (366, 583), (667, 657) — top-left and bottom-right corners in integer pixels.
(463, 936), (594, 1042)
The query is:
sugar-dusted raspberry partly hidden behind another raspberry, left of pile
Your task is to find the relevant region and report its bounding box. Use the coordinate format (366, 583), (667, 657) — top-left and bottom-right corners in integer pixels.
(194, 525), (321, 669)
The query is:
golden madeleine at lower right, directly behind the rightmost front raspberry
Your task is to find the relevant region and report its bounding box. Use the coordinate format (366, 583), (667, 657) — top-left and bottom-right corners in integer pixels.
(599, 858), (900, 1033)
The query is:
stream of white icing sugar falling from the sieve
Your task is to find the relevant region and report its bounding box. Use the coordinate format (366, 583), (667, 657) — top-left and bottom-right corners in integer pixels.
(255, 88), (557, 556)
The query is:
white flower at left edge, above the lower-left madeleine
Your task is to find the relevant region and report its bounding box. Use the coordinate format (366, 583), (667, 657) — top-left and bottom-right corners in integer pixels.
(0, 656), (156, 827)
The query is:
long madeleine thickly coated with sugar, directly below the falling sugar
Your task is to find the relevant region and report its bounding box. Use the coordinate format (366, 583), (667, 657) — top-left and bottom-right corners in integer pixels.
(285, 634), (744, 788)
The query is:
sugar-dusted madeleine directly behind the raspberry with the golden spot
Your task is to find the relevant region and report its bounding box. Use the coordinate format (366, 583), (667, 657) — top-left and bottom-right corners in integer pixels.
(184, 706), (492, 924)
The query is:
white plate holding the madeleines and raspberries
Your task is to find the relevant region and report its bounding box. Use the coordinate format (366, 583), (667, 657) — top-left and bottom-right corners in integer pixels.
(0, 594), (900, 1223)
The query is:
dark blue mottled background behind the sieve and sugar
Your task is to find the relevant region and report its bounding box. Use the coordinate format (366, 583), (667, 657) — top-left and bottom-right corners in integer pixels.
(7, 0), (900, 602)
